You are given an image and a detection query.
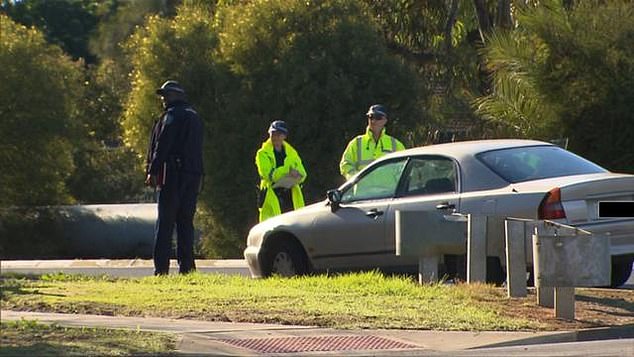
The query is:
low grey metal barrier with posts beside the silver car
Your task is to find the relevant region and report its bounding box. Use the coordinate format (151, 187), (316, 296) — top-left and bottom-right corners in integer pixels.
(395, 210), (610, 319)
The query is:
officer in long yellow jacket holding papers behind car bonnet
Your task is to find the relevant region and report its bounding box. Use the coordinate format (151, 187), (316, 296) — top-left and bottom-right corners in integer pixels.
(255, 120), (306, 222)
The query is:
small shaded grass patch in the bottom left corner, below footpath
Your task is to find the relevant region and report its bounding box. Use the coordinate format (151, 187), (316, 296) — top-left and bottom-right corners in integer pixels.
(0, 320), (176, 356)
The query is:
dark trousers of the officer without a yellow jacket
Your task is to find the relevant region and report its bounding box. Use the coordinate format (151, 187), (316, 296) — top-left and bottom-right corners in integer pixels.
(154, 172), (201, 275)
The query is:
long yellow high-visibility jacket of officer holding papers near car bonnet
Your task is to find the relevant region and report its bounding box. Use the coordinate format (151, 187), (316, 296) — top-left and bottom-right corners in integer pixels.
(255, 139), (306, 222)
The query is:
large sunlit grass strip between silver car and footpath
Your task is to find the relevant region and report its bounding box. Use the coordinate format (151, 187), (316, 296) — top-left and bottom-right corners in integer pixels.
(2, 272), (539, 330)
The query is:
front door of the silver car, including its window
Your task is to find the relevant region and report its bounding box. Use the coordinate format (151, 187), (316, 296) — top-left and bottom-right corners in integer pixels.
(312, 157), (407, 270)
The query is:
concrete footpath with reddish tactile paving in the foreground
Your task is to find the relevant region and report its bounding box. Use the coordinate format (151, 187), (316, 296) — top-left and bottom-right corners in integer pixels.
(1, 310), (634, 356)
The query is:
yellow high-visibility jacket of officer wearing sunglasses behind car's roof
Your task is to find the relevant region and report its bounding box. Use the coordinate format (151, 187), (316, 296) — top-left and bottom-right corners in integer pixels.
(339, 127), (405, 180)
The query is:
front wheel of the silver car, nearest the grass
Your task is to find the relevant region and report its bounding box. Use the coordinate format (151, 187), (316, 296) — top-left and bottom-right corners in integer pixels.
(263, 241), (308, 277)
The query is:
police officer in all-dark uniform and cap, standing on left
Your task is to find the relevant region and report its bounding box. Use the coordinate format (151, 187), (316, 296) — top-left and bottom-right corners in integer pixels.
(145, 80), (203, 275)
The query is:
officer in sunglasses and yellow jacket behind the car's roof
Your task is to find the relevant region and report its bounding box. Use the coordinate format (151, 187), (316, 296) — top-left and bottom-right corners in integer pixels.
(339, 104), (405, 180)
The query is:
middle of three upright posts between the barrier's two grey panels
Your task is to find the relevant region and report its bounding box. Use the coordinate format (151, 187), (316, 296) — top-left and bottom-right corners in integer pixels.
(505, 220), (526, 297)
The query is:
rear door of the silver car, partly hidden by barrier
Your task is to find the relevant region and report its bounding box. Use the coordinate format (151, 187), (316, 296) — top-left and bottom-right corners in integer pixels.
(384, 155), (460, 271)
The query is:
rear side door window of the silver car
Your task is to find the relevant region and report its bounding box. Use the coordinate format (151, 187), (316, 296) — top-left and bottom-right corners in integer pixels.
(403, 157), (456, 196)
